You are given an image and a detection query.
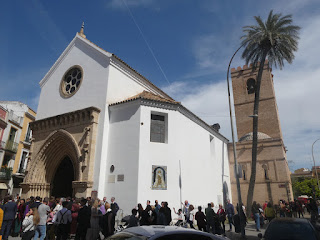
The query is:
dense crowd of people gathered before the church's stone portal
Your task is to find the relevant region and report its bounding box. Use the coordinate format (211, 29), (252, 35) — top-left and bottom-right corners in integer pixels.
(0, 196), (119, 240)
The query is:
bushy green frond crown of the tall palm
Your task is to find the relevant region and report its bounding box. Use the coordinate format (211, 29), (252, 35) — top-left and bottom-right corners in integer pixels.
(241, 10), (300, 69)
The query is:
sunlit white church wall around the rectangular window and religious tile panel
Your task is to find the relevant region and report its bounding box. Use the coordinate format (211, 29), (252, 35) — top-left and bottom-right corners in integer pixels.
(138, 106), (230, 214)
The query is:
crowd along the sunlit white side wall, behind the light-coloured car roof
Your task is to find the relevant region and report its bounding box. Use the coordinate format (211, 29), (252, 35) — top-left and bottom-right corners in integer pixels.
(127, 200), (245, 235)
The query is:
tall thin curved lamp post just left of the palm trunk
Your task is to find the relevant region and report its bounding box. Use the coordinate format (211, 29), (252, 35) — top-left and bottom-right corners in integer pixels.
(227, 44), (245, 237)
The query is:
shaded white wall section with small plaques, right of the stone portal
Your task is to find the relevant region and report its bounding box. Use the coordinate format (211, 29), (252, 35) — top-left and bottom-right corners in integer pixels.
(104, 103), (141, 214)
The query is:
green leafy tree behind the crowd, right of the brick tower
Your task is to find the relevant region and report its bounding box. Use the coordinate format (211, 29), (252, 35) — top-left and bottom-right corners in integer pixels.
(292, 178), (320, 198)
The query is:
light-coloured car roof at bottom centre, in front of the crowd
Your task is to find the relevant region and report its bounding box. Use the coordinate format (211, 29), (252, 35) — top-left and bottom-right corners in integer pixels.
(107, 225), (229, 240)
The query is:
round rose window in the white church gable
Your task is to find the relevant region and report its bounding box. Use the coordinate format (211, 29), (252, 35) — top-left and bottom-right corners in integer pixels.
(60, 67), (83, 97)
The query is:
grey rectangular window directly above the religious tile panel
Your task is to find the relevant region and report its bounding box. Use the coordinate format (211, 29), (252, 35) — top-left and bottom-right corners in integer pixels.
(150, 114), (166, 143)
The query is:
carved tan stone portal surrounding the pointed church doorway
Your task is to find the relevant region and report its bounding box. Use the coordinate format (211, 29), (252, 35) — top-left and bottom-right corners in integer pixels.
(21, 107), (100, 198)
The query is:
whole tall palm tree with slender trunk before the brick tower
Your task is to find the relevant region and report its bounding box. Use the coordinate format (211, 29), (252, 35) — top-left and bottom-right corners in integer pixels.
(241, 10), (300, 216)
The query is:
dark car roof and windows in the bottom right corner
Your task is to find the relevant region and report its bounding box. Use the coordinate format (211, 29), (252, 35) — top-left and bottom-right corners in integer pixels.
(258, 218), (320, 240)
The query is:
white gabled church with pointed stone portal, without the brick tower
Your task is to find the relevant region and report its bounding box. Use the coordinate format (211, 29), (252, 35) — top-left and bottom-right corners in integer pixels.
(21, 29), (231, 214)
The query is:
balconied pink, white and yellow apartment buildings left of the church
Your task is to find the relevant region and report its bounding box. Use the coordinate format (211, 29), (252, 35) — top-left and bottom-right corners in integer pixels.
(0, 101), (36, 197)
